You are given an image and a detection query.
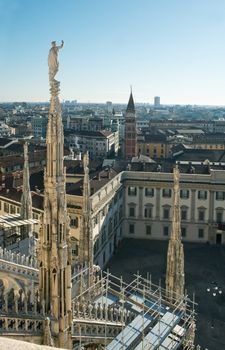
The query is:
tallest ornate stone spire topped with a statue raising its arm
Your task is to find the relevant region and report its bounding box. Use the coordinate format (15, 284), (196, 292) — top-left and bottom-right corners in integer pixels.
(39, 42), (71, 348)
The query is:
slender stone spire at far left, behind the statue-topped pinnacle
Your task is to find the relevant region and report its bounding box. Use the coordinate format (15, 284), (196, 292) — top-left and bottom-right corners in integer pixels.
(20, 142), (32, 239)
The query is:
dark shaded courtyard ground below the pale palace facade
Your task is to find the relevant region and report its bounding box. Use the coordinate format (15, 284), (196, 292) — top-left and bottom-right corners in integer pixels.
(108, 239), (225, 350)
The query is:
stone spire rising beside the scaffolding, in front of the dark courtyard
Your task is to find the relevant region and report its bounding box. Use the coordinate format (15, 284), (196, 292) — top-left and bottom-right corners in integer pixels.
(166, 167), (184, 301)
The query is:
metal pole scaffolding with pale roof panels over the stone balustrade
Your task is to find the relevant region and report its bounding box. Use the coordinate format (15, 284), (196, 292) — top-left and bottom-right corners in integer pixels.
(72, 272), (195, 350)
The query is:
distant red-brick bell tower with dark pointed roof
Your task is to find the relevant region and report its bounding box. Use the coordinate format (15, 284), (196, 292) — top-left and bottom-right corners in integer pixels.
(124, 91), (137, 159)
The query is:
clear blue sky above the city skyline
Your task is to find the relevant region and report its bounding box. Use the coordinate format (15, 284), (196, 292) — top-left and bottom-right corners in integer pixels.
(0, 0), (225, 105)
